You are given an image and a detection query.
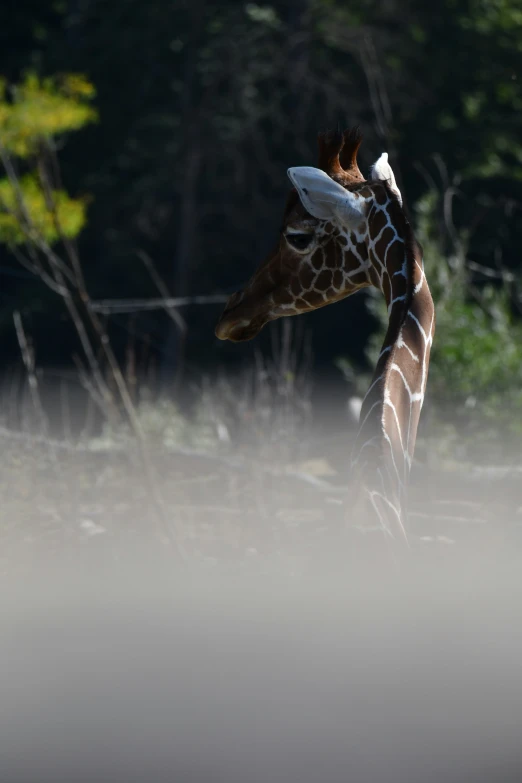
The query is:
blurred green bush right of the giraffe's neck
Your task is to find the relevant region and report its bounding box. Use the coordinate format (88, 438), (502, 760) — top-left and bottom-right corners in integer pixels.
(417, 189), (522, 422)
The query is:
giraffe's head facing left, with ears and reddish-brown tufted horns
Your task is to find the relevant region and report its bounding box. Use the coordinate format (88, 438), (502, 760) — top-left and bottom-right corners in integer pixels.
(216, 129), (400, 342)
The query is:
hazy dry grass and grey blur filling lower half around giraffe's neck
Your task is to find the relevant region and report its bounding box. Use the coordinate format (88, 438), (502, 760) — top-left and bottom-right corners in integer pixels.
(0, 376), (522, 783)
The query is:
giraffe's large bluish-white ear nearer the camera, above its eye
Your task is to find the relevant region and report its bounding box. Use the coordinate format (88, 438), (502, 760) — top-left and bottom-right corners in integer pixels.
(288, 166), (365, 228)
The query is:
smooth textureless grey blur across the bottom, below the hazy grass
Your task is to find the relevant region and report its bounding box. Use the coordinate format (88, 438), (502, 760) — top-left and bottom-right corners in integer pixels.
(4, 553), (522, 783)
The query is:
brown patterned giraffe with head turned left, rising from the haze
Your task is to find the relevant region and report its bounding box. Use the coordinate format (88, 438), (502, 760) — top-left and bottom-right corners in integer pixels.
(216, 128), (435, 544)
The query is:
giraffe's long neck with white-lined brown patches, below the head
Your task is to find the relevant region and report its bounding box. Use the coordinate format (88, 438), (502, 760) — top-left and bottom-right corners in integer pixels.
(352, 199), (434, 534)
